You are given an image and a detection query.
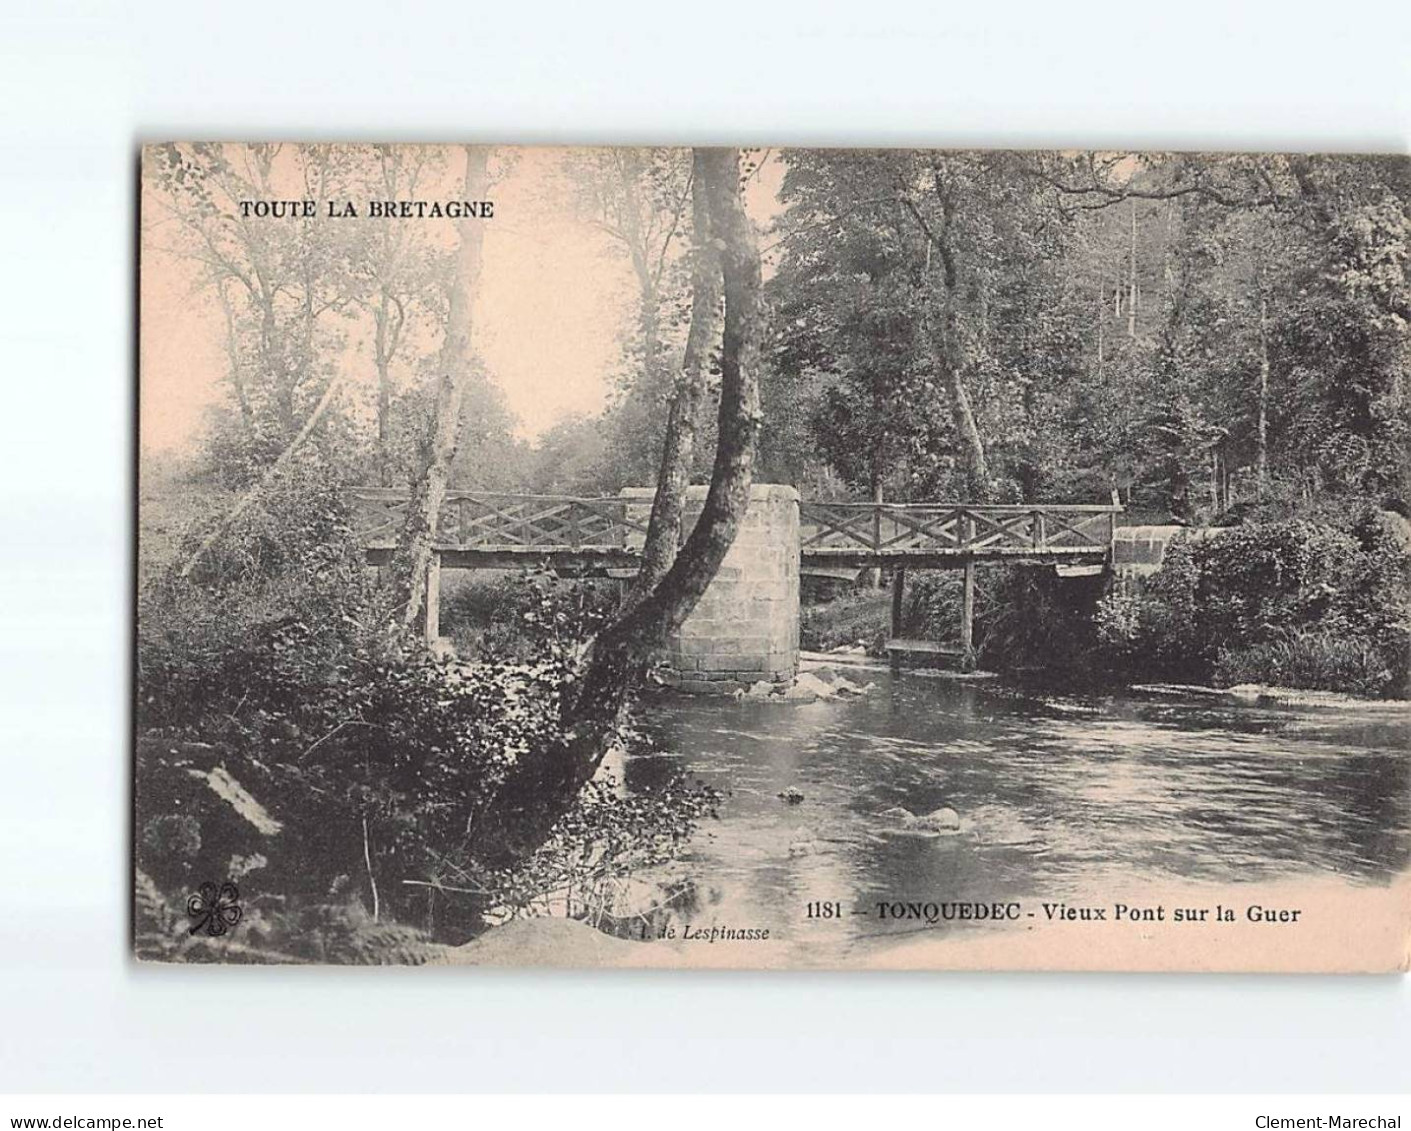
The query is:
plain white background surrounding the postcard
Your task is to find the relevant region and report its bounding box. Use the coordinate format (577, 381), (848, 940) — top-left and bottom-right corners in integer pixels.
(0, 0), (1411, 1094)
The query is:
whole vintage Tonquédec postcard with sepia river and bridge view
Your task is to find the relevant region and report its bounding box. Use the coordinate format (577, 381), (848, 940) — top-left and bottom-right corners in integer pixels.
(133, 142), (1411, 972)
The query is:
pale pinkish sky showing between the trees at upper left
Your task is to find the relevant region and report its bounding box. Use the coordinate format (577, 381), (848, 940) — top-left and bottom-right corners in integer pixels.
(140, 148), (783, 451)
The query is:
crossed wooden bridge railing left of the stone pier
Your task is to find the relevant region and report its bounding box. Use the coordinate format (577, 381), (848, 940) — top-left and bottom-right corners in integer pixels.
(351, 487), (646, 550)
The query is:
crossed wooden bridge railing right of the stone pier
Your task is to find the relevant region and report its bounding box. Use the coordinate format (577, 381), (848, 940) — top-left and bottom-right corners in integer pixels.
(799, 502), (1122, 557)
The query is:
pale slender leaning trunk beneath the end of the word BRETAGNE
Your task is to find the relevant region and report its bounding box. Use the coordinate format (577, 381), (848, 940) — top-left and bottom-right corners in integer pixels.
(392, 145), (485, 629)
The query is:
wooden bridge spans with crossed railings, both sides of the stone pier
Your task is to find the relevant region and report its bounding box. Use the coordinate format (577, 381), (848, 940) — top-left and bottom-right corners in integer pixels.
(353, 487), (1122, 573)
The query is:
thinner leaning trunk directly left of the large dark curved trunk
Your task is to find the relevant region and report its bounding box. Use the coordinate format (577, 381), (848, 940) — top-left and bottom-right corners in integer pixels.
(628, 149), (721, 608)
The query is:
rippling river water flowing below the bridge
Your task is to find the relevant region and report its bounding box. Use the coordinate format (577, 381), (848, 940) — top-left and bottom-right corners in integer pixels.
(622, 670), (1411, 963)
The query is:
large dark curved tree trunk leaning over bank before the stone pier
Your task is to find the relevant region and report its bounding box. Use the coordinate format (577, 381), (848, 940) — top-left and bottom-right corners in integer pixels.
(471, 149), (761, 867)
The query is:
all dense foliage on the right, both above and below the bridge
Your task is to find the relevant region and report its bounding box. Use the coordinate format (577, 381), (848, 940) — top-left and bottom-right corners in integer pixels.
(762, 151), (1411, 694)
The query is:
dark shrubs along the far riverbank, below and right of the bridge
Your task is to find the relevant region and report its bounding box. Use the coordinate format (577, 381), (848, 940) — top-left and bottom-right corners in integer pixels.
(804, 506), (1411, 697)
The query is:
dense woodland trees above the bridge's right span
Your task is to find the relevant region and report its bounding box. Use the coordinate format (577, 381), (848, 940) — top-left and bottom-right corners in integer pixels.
(762, 151), (1411, 520)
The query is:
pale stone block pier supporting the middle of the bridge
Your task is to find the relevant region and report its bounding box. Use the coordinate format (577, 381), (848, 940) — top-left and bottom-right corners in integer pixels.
(622, 484), (800, 694)
